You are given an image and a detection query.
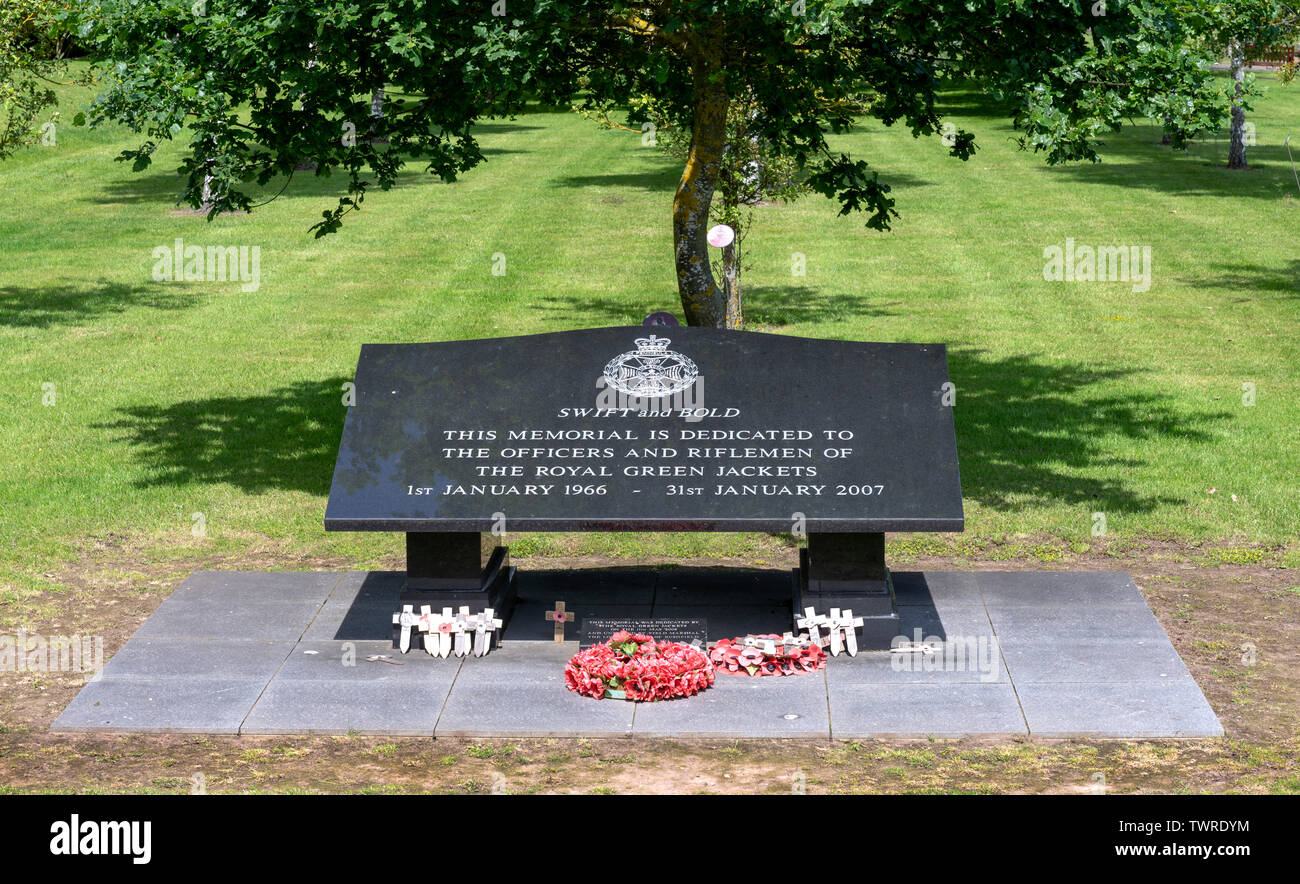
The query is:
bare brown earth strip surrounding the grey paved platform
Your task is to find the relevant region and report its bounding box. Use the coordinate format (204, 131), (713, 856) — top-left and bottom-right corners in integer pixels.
(0, 536), (1300, 794)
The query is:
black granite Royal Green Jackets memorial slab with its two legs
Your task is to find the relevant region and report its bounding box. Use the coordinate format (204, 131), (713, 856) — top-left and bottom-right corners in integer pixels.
(325, 326), (963, 644)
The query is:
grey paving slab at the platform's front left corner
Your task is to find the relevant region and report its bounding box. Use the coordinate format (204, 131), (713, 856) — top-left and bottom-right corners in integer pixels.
(49, 679), (267, 733)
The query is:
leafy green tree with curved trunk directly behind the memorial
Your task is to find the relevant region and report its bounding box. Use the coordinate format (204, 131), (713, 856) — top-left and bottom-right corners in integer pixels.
(82, 0), (1253, 326)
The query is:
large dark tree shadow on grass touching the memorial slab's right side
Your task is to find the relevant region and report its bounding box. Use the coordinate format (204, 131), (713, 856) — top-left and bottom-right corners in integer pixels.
(948, 348), (1231, 519)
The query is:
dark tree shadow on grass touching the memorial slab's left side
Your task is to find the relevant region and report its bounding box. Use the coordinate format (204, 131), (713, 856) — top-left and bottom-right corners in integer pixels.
(96, 376), (352, 495)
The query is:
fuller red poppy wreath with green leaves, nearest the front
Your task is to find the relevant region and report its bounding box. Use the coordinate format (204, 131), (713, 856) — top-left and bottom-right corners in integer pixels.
(564, 631), (714, 702)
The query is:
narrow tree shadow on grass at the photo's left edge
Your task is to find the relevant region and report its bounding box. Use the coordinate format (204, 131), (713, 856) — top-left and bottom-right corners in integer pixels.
(0, 280), (200, 329)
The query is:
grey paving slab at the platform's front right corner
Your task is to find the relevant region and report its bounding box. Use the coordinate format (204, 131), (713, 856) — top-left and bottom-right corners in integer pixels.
(1018, 679), (1223, 738)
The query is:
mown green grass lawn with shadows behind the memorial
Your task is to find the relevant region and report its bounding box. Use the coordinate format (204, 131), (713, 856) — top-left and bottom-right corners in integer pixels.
(0, 67), (1300, 593)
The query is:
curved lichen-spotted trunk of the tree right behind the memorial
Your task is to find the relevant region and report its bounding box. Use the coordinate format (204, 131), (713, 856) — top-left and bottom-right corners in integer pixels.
(672, 61), (738, 329)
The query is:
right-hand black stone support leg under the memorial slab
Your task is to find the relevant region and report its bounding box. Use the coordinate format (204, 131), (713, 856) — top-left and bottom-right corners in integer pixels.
(794, 533), (900, 650)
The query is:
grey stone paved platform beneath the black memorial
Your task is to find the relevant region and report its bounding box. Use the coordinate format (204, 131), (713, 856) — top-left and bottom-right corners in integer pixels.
(52, 568), (1223, 738)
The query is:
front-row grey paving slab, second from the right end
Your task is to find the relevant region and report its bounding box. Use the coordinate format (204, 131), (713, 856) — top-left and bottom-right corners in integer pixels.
(829, 683), (1027, 740)
